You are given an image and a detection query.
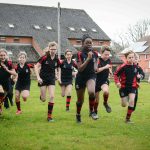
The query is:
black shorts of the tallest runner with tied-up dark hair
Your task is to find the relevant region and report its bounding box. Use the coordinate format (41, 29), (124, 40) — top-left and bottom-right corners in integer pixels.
(75, 74), (96, 90)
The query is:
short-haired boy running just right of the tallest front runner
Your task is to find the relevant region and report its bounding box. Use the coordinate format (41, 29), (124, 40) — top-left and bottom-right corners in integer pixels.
(94, 46), (112, 119)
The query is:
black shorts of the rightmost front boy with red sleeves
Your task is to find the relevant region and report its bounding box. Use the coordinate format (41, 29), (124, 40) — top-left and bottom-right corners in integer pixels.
(119, 87), (137, 97)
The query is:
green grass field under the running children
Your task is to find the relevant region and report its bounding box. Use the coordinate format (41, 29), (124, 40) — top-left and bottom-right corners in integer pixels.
(0, 81), (150, 150)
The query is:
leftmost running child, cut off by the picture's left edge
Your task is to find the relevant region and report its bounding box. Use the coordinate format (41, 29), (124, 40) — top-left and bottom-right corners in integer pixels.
(0, 49), (16, 114)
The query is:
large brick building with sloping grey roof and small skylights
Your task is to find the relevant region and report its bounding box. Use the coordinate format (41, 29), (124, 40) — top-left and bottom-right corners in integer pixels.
(0, 4), (120, 68)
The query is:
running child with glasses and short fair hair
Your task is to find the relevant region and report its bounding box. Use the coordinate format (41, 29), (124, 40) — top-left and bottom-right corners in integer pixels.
(35, 42), (60, 122)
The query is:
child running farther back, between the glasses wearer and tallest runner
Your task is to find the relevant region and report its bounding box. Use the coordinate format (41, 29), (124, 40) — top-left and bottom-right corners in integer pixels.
(58, 49), (77, 111)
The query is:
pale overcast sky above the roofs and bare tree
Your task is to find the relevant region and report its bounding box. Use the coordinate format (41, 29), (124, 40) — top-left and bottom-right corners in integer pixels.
(0, 0), (150, 41)
